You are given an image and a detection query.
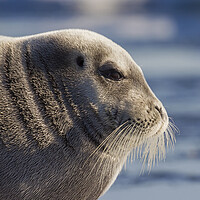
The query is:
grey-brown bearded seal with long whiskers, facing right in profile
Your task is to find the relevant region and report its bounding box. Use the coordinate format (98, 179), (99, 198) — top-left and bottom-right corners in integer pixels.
(0, 29), (174, 200)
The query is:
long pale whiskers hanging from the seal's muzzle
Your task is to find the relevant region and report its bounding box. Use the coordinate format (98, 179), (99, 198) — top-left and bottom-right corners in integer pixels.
(88, 118), (177, 173)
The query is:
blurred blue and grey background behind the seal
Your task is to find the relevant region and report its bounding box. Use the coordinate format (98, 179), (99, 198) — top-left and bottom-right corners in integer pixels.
(0, 0), (200, 200)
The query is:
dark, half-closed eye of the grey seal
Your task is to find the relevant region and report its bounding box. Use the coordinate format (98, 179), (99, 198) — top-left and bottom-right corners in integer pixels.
(99, 67), (123, 81)
